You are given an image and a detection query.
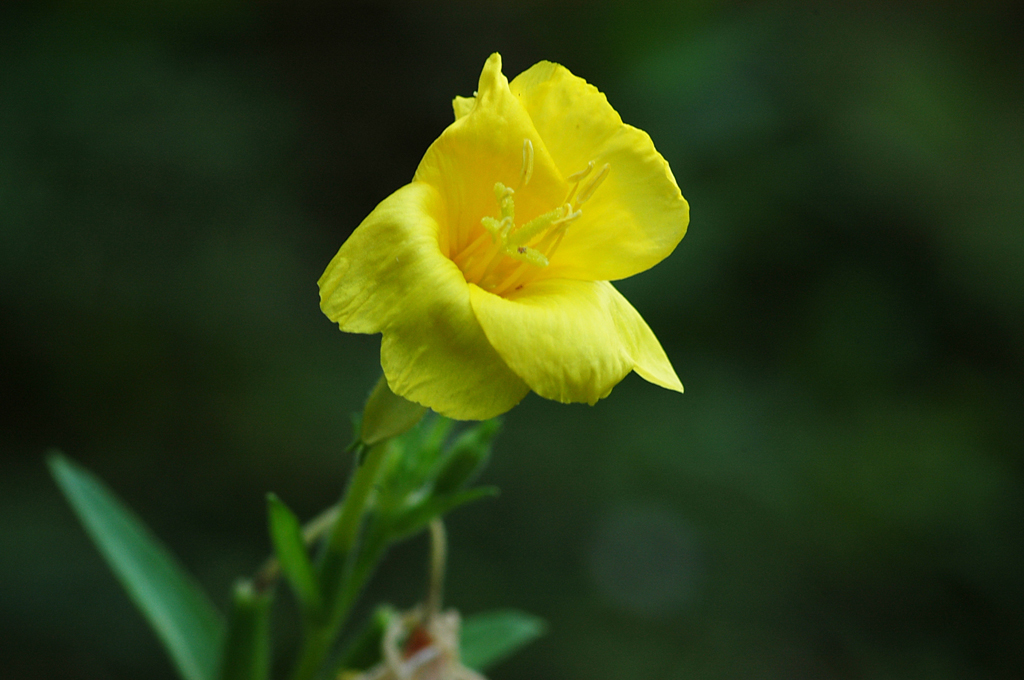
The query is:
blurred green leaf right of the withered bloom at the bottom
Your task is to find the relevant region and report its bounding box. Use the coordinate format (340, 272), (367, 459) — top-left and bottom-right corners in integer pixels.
(461, 609), (547, 672)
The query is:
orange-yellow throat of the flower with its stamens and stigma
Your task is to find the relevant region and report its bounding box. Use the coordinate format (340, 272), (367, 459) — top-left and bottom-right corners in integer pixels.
(453, 139), (610, 295)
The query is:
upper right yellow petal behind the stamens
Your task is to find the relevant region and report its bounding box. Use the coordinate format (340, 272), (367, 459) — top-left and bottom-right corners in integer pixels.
(510, 61), (689, 281)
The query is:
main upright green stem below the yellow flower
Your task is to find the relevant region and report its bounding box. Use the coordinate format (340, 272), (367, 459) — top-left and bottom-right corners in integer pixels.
(291, 441), (388, 680)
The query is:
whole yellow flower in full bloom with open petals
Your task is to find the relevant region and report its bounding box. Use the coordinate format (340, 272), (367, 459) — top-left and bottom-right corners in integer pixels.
(319, 54), (689, 420)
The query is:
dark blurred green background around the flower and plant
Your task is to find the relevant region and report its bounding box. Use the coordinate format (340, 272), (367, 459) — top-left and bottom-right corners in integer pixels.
(0, 0), (1024, 680)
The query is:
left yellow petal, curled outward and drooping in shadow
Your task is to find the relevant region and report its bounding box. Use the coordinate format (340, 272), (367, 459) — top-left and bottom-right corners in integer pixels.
(319, 182), (528, 420)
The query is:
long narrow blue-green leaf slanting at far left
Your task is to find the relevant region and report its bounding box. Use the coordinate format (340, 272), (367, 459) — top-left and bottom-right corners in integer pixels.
(47, 453), (224, 680)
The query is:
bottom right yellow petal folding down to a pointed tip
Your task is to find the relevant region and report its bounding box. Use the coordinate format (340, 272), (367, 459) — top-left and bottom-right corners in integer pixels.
(469, 279), (683, 403)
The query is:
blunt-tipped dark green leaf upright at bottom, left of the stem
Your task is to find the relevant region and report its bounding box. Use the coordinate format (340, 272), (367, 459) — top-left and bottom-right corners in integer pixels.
(219, 581), (271, 680)
